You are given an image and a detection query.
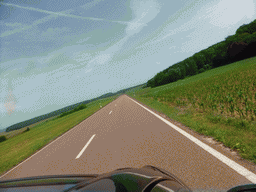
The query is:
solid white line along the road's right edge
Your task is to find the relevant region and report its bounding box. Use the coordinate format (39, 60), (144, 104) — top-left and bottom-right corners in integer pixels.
(128, 97), (256, 184)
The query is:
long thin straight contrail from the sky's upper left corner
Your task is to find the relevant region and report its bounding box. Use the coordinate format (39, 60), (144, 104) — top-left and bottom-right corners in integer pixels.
(2, 3), (147, 25)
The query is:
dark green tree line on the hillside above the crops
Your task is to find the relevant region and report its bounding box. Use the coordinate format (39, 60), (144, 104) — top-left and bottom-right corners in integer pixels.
(145, 19), (256, 88)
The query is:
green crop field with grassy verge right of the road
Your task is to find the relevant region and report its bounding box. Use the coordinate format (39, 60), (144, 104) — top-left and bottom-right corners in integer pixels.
(126, 57), (256, 164)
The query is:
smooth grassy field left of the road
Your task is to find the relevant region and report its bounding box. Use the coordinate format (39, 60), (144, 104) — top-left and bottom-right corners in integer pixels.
(0, 95), (119, 175)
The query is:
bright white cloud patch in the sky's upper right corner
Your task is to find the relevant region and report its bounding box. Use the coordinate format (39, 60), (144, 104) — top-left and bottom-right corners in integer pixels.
(143, 0), (255, 49)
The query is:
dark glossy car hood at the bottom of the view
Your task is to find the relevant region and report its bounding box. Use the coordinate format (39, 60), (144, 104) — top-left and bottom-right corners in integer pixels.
(0, 165), (256, 192)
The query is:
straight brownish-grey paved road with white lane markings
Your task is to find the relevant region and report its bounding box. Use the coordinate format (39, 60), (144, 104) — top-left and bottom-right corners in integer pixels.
(0, 95), (256, 191)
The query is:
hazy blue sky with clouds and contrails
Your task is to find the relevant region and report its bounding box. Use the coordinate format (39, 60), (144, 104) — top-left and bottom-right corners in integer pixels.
(0, 0), (256, 129)
